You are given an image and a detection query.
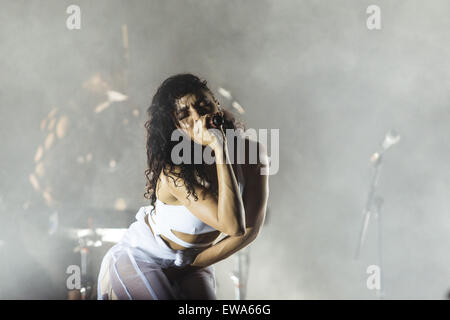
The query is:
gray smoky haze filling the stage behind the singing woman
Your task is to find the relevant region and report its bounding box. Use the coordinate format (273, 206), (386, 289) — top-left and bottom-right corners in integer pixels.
(0, 0), (450, 299)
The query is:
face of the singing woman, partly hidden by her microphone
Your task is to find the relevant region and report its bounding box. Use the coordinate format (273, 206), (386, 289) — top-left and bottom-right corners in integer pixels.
(174, 91), (220, 131)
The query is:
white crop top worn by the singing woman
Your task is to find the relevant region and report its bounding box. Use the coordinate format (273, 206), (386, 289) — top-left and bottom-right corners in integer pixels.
(145, 164), (245, 248)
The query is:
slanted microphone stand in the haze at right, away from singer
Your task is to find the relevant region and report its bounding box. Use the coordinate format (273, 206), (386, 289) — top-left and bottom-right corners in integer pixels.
(355, 154), (384, 299)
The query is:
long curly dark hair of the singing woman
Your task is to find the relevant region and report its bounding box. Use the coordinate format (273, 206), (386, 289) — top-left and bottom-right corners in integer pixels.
(144, 73), (245, 209)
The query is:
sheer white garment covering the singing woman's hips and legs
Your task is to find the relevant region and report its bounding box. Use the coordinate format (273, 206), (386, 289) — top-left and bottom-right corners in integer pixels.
(97, 208), (216, 300)
